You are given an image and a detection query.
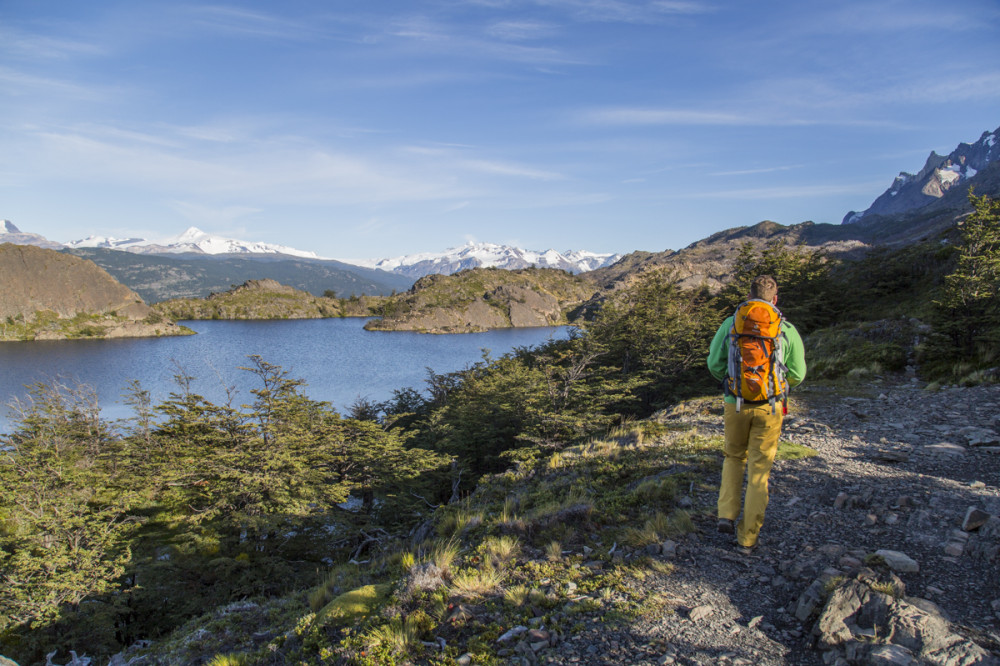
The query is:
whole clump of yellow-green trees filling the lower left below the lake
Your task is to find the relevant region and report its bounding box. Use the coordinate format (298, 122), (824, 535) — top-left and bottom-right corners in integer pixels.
(0, 356), (447, 661)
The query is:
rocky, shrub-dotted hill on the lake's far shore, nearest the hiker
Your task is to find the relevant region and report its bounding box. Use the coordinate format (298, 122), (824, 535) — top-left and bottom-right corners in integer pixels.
(366, 268), (595, 333)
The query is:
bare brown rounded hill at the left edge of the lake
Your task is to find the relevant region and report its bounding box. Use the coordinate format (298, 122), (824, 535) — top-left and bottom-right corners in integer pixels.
(0, 243), (189, 340)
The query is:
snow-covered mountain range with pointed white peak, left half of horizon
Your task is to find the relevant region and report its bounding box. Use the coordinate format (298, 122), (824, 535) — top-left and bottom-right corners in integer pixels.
(66, 227), (322, 259)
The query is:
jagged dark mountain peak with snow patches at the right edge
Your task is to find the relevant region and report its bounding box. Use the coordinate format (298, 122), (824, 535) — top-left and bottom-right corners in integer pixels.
(843, 128), (1000, 224)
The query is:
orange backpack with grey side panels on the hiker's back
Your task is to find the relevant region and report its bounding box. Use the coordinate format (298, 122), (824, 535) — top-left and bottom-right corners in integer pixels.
(726, 298), (788, 413)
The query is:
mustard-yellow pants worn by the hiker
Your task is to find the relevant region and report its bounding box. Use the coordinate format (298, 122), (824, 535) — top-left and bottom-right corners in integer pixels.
(719, 402), (782, 547)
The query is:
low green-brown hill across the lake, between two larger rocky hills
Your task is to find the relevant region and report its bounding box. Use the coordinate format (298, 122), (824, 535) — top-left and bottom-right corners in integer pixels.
(153, 280), (368, 319)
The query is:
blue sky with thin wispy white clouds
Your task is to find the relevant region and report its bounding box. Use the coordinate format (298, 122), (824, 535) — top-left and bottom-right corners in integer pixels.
(0, 0), (1000, 258)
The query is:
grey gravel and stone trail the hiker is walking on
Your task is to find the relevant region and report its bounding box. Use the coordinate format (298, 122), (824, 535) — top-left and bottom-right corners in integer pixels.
(541, 378), (1000, 665)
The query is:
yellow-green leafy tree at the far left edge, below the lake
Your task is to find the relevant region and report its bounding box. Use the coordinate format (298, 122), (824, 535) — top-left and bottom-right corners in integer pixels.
(0, 384), (139, 649)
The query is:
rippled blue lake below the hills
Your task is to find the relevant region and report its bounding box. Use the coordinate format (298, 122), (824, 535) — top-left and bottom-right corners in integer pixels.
(0, 319), (567, 432)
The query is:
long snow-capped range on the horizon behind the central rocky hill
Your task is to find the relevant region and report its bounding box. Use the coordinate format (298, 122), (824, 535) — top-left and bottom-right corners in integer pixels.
(343, 242), (621, 278)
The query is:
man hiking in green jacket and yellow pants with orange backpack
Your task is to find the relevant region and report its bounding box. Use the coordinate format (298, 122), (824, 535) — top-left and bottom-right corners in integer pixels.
(708, 275), (806, 554)
